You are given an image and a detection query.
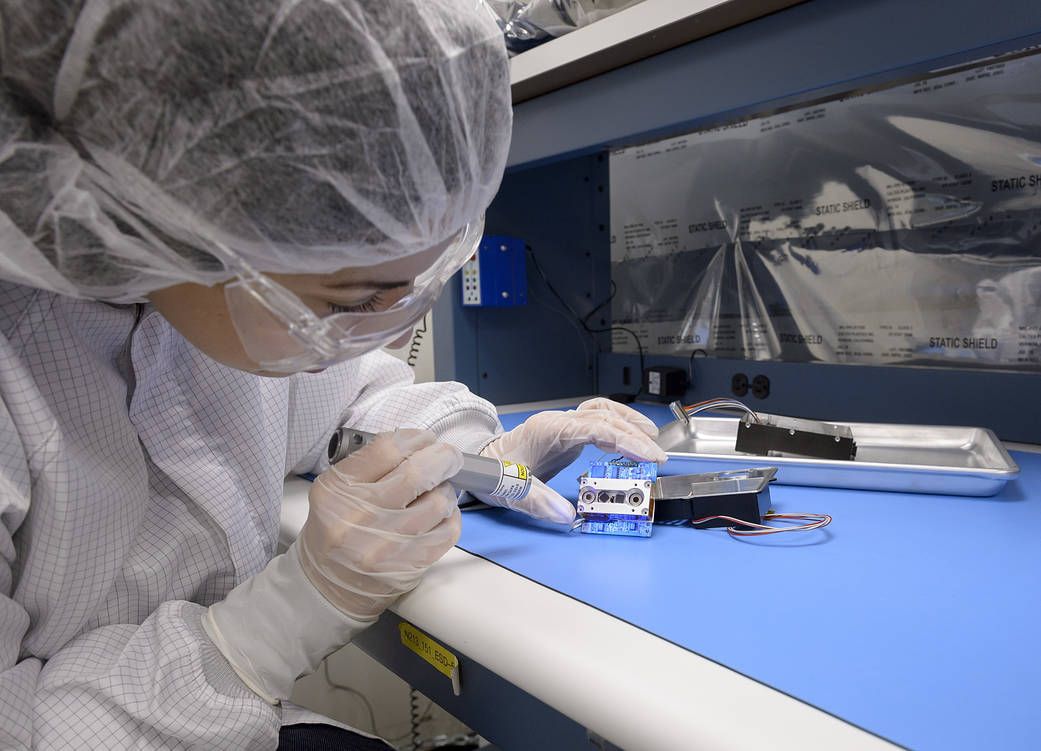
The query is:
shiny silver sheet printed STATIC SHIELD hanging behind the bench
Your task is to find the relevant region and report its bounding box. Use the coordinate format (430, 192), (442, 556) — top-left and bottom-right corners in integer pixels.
(610, 52), (1041, 371)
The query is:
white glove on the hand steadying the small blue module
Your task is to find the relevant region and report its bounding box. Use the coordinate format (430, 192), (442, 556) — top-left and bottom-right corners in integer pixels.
(478, 398), (668, 524)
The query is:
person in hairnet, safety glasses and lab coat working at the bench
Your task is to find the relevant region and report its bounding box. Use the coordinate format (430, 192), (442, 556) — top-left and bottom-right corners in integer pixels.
(0, 0), (661, 749)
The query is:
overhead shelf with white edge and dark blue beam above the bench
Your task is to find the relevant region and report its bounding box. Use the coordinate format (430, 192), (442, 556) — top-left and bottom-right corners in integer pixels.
(509, 0), (1041, 168)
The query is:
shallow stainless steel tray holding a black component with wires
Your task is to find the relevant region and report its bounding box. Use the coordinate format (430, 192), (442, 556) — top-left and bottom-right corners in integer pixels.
(658, 418), (1019, 496)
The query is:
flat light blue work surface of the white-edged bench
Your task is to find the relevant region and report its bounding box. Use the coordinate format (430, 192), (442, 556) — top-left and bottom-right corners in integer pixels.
(459, 406), (1041, 751)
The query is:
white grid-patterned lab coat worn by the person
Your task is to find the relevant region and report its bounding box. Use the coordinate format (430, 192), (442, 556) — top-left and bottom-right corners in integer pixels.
(0, 282), (501, 749)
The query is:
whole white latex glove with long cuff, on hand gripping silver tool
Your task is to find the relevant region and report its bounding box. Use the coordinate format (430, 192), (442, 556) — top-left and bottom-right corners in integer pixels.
(203, 430), (462, 704)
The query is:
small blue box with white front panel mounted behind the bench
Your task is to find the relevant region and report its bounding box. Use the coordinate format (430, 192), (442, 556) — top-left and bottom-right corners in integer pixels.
(462, 234), (528, 307)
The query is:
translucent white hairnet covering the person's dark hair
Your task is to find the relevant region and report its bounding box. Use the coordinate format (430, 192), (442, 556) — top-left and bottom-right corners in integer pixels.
(0, 0), (511, 301)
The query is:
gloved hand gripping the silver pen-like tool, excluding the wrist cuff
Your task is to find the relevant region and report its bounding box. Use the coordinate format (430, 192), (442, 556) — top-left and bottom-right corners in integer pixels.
(297, 429), (462, 621)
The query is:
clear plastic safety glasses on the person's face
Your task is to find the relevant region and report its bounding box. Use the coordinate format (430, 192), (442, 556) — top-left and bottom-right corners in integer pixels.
(224, 219), (484, 374)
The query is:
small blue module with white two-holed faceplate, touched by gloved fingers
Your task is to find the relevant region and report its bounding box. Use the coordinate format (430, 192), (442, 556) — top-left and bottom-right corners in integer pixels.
(575, 458), (658, 537)
